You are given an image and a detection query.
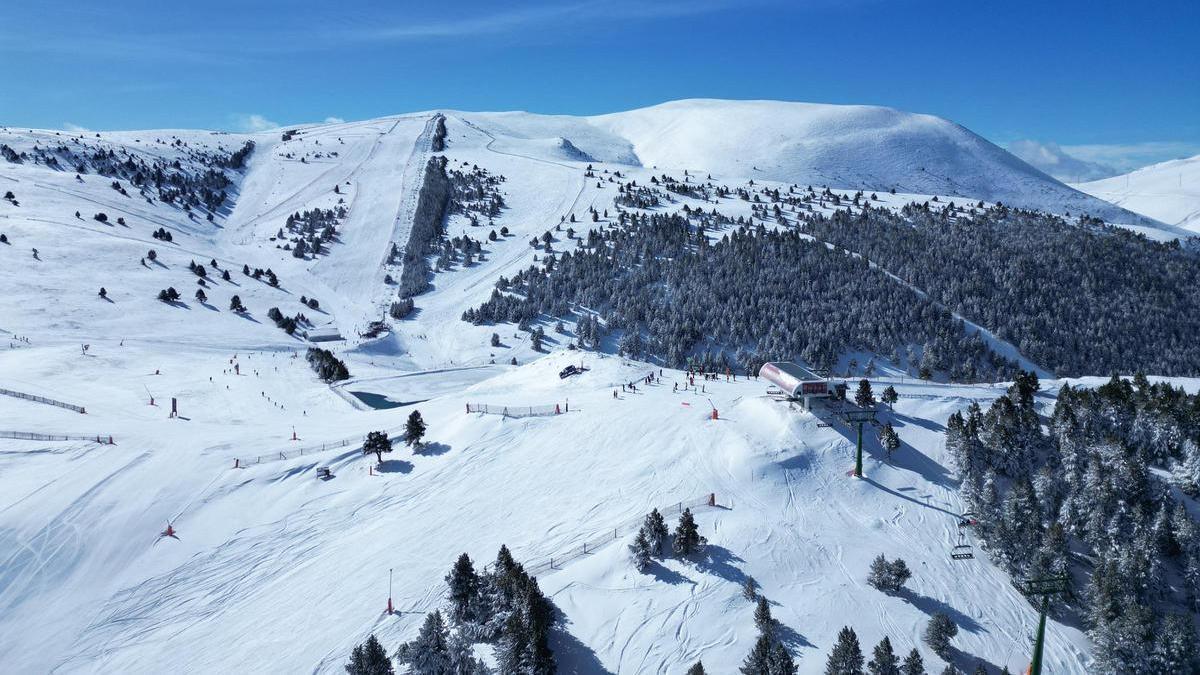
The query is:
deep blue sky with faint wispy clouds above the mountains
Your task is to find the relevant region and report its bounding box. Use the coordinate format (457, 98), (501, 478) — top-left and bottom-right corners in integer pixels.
(0, 0), (1200, 168)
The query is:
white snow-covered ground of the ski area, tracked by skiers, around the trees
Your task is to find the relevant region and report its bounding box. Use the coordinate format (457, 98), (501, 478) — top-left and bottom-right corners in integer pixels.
(0, 103), (1171, 673)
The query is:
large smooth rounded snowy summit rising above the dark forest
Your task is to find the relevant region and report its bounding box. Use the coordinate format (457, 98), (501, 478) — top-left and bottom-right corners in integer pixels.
(589, 100), (1153, 225)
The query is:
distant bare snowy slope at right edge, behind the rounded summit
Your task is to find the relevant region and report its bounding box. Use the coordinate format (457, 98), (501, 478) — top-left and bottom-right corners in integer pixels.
(1074, 155), (1200, 233)
